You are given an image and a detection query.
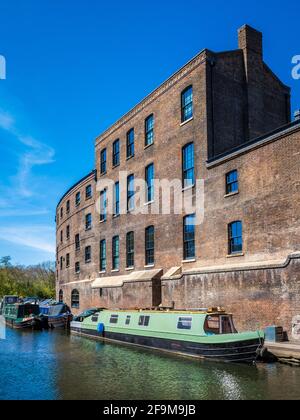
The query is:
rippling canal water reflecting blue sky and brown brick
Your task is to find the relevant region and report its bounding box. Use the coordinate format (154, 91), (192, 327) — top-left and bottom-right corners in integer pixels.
(0, 330), (300, 400)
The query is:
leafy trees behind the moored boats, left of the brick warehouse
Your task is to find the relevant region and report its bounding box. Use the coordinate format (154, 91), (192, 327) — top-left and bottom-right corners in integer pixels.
(0, 256), (55, 298)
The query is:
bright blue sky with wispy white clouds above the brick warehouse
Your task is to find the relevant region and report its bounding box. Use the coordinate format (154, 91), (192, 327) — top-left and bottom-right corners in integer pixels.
(0, 0), (300, 264)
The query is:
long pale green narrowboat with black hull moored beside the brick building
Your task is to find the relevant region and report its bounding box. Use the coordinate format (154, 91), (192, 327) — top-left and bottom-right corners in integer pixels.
(71, 308), (264, 363)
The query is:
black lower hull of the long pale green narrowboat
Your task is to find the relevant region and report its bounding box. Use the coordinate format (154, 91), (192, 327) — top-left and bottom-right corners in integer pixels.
(71, 325), (263, 364)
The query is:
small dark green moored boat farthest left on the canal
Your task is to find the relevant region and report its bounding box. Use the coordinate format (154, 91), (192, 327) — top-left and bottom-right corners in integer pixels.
(3, 303), (40, 329)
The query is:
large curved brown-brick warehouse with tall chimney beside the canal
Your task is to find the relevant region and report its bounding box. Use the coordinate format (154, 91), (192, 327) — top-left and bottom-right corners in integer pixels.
(57, 26), (300, 340)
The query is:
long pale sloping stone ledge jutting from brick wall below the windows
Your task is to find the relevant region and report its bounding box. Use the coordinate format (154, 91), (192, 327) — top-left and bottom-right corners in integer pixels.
(92, 269), (163, 289)
